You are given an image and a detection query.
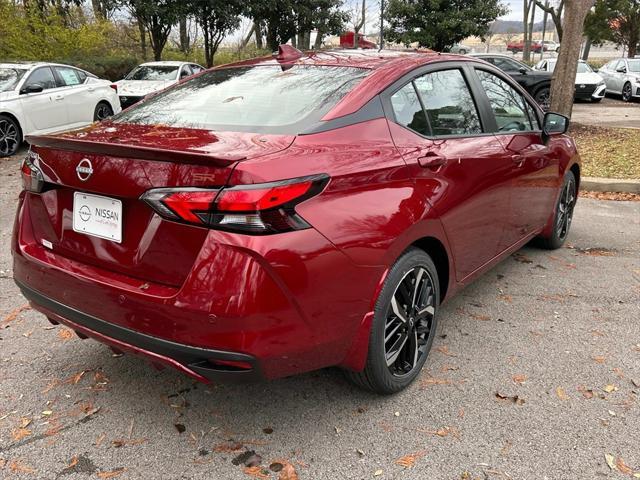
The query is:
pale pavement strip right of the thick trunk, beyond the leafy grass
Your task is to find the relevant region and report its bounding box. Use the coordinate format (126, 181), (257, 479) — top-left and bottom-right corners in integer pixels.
(571, 96), (640, 128)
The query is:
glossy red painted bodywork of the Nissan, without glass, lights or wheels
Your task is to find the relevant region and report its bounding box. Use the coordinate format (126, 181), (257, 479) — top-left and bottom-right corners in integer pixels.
(12, 51), (579, 381)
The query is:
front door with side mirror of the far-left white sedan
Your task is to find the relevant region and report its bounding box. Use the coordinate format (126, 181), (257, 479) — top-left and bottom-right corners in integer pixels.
(20, 67), (69, 131)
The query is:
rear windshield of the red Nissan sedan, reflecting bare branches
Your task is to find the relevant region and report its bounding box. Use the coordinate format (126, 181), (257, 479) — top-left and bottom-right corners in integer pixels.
(114, 65), (369, 134)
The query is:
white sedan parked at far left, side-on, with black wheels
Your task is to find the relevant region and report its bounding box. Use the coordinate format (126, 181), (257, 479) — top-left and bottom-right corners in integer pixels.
(0, 62), (120, 157)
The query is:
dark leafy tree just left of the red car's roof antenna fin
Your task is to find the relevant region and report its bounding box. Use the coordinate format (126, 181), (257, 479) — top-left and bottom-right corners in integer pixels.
(186, 0), (244, 68)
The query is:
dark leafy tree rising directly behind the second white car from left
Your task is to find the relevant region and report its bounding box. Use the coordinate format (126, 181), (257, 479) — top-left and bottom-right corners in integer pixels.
(127, 0), (185, 60)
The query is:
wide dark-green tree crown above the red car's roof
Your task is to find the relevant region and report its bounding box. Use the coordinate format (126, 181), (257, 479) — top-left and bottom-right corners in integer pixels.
(384, 0), (508, 51)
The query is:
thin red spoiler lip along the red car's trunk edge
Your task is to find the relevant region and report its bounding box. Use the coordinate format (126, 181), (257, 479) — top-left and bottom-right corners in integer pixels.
(25, 135), (247, 167)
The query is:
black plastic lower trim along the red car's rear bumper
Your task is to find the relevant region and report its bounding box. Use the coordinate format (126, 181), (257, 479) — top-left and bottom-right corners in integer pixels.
(15, 280), (264, 383)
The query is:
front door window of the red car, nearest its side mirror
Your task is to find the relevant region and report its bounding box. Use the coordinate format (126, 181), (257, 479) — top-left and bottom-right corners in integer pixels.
(476, 70), (534, 132)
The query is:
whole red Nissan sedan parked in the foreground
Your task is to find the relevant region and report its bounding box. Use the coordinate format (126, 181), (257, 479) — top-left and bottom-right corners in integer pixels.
(12, 47), (580, 393)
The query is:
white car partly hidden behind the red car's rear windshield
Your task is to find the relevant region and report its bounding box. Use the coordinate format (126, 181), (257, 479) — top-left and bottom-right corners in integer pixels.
(115, 62), (205, 108)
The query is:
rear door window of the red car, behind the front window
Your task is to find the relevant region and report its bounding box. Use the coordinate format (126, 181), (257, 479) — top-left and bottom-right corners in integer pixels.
(414, 69), (482, 136)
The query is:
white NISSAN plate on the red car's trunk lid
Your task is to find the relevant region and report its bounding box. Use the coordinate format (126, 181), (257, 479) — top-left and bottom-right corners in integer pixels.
(73, 192), (122, 243)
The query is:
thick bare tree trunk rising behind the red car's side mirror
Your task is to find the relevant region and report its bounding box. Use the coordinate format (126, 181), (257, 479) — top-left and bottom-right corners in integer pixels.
(550, 0), (595, 117)
